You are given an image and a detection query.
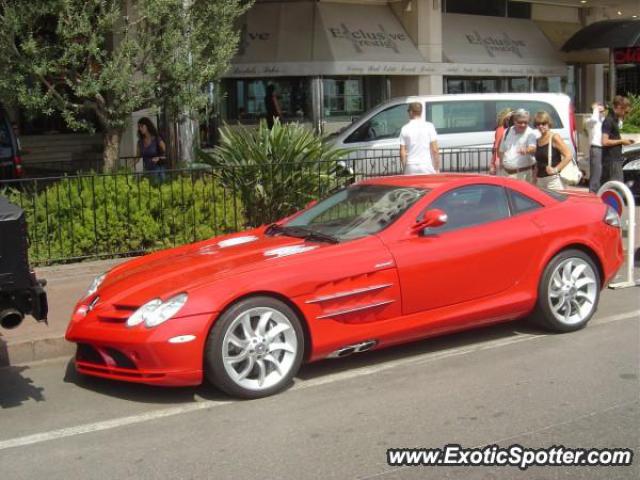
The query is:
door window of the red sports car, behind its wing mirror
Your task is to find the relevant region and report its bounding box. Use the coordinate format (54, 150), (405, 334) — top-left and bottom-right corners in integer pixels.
(428, 185), (509, 233)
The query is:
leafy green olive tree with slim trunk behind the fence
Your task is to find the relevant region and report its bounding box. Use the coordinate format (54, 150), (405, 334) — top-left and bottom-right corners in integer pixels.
(0, 0), (249, 169)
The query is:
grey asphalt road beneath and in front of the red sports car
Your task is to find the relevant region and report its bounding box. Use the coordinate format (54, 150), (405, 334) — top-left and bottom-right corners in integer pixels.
(0, 288), (640, 480)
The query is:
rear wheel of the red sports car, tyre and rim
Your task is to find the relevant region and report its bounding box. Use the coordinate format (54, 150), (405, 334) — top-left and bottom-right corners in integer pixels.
(533, 249), (600, 332)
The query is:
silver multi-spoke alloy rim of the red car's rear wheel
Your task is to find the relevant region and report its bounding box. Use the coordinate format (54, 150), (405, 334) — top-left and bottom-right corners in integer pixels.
(547, 257), (598, 325)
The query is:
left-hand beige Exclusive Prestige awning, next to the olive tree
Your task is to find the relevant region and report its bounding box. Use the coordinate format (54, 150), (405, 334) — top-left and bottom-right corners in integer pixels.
(226, 2), (425, 77)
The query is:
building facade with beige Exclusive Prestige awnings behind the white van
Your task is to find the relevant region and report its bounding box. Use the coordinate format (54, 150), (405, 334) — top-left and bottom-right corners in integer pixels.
(219, 0), (640, 132)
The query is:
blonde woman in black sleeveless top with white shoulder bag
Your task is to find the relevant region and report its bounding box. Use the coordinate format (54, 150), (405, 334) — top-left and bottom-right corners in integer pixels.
(533, 112), (573, 190)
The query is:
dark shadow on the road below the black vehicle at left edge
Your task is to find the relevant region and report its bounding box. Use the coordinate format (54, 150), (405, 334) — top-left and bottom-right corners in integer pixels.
(0, 338), (45, 409)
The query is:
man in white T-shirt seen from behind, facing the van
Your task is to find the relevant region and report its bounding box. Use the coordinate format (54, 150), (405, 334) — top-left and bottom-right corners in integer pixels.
(400, 102), (440, 175)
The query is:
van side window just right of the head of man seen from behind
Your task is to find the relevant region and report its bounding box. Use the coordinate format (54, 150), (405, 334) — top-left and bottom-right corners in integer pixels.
(426, 100), (496, 134)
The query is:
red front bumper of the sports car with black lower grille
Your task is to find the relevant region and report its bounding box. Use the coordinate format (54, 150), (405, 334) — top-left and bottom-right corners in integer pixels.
(65, 312), (213, 386)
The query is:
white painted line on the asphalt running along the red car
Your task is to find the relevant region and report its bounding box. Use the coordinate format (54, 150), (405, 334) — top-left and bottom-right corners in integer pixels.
(0, 310), (640, 451)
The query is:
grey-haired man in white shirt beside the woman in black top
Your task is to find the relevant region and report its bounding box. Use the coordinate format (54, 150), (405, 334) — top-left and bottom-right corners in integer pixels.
(499, 108), (537, 184)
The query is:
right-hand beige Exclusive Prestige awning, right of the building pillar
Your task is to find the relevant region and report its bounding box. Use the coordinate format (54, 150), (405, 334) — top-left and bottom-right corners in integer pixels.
(442, 14), (567, 76)
